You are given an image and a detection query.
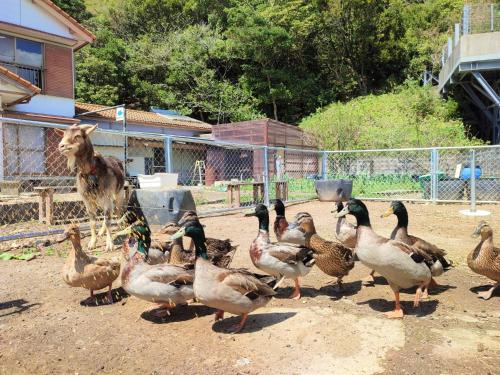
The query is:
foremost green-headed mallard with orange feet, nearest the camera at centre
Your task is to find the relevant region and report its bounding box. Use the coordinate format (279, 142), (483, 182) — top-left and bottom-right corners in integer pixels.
(172, 220), (276, 332)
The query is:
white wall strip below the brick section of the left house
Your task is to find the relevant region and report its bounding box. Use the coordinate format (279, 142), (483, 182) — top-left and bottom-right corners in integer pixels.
(9, 94), (75, 117)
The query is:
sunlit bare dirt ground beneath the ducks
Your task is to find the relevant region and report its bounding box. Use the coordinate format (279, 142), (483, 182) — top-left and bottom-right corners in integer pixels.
(0, 202), (500, 374)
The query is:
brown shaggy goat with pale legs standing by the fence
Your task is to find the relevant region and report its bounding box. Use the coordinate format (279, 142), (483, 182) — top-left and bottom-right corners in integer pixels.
(55, 124), (125, 251)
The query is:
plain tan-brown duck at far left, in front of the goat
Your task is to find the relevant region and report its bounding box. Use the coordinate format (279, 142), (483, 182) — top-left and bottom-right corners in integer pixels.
(62, 224), (120, 304)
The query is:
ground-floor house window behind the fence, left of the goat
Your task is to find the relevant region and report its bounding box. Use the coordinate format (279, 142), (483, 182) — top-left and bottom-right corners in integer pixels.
(3, 124), (45, 176)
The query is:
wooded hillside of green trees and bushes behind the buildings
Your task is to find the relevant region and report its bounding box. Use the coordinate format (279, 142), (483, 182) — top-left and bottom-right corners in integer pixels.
(72, 0), (478, 145)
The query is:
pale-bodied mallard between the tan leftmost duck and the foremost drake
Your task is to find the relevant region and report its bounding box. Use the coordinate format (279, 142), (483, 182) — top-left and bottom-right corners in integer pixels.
(121, 237), (194, 317)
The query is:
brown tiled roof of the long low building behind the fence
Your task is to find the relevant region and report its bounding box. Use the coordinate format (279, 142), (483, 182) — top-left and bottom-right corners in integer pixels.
(75, 102), (212, 133)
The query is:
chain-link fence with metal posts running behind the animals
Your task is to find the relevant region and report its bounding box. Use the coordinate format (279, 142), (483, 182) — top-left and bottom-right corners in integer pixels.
(0, 117), (500, 234)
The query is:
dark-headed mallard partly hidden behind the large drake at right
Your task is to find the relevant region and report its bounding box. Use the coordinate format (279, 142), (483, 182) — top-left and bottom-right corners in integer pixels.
(381, 201), (451, 276)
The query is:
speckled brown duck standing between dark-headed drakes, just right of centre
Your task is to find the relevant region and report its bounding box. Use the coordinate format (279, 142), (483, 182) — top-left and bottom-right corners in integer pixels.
(297, 213), (354, 291)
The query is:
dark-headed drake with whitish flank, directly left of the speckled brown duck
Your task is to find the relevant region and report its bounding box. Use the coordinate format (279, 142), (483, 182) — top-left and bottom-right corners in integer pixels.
(245, 204), (315, 299)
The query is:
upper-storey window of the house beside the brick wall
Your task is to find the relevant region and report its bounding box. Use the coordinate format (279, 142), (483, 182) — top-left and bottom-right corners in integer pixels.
(0, 34), (43, 88)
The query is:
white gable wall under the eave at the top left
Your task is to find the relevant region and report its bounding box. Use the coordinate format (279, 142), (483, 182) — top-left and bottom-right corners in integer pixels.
(0, 0), (75, 39)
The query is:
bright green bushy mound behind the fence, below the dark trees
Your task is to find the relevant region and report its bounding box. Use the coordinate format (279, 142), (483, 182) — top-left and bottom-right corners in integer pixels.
(300, 81), (480, 150)
